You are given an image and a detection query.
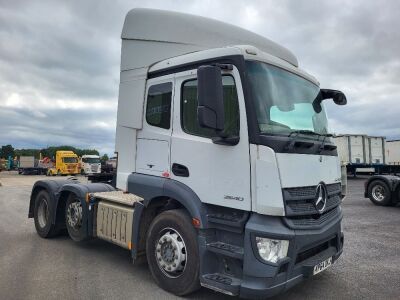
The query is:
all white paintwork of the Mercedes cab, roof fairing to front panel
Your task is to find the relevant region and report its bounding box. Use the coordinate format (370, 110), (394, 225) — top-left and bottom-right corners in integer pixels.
(116, 9), (341, 216)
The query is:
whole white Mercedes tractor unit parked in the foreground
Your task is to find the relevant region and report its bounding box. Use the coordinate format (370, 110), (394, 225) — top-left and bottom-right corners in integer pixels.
(29, 9), (346, 298)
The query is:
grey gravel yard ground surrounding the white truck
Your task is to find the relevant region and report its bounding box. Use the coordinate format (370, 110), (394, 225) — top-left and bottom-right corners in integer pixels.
(0, 172), (400, 299)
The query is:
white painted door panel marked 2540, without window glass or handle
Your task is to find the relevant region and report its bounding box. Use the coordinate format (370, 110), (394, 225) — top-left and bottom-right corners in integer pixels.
(171, 68), (251, 211)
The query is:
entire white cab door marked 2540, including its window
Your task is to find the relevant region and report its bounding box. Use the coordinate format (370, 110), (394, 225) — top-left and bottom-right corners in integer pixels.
(171, 67), (251, 210)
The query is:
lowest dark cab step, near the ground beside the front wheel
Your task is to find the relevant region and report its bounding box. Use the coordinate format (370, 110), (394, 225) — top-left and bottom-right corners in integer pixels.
(200, 273), (241, 296)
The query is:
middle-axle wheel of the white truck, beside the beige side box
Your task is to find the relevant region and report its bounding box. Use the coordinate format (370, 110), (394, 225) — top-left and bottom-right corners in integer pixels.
(65, 194), (87, 242)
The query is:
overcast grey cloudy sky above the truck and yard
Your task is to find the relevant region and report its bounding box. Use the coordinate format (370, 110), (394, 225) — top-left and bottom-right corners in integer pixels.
(0, 0), (400, 154)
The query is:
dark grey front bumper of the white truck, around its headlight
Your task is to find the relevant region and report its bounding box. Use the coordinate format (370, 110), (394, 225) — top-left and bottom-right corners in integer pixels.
(240, 211), (344, 298)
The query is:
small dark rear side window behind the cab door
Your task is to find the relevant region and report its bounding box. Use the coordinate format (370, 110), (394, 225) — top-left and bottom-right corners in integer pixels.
(146, 82), (172, 129)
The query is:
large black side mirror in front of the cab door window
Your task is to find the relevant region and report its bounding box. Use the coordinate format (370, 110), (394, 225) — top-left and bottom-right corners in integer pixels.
(197, 66), (224, 132)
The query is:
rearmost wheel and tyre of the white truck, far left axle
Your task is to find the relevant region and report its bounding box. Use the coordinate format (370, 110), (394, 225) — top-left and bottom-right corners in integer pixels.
(33, 190), (58, 238)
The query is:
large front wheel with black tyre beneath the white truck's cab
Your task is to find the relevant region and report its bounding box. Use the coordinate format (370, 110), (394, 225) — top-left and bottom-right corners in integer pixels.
(146, 209), (200, 296)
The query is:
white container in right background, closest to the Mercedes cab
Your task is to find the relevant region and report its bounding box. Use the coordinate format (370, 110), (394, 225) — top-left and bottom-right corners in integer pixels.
(333, 134), (370, 165)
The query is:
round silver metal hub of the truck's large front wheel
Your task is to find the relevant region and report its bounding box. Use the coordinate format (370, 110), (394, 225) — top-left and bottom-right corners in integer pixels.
(156, 229), (186, 278)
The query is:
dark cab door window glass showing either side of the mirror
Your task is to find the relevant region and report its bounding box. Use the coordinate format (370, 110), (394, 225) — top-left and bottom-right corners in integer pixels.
(181, 75), (239, 137)
